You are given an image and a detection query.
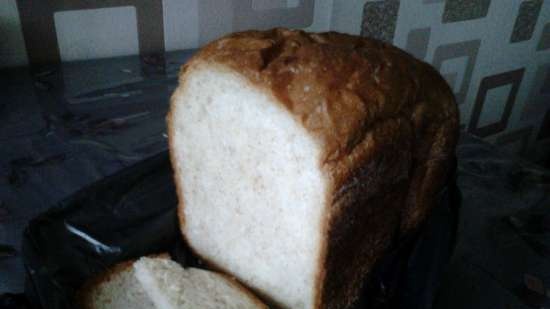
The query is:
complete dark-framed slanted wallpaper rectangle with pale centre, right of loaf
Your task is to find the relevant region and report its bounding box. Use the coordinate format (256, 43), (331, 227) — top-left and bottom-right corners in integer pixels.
(468, 68), (525, 137)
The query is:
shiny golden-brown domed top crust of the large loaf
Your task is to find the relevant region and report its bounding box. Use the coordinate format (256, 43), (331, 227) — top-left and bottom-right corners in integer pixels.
(183, 28), (458, 171)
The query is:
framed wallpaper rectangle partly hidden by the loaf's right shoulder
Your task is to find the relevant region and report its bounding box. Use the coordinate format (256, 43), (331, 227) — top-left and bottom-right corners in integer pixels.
(433, 40), (481, 104)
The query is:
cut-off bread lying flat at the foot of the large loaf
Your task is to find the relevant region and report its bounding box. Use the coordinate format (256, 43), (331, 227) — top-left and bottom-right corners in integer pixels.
(78, 255), (267, 309)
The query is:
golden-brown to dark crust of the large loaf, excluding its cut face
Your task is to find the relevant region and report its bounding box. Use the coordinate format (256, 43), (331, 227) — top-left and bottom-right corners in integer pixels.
(168, 29), (458, 308)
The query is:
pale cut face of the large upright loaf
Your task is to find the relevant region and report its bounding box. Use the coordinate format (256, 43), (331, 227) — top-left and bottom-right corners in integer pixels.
(169, 63), (328, 308)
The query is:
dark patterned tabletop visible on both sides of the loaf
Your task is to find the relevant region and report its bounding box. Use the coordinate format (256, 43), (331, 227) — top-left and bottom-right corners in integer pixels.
(0, 51), (550, 308)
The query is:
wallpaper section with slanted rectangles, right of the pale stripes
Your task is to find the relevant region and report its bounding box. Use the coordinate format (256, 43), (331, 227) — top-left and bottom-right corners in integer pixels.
(361, 0), (550, 164)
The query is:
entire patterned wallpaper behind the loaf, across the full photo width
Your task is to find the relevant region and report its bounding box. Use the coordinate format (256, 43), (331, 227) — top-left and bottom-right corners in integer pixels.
(0, 0), (550, 164)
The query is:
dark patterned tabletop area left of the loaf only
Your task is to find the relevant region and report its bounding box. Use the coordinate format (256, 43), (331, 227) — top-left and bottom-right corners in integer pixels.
(0, 51), (193, 294)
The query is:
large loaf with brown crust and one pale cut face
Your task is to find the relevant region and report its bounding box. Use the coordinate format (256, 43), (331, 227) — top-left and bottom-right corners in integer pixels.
(167, 29), (458, 309)
